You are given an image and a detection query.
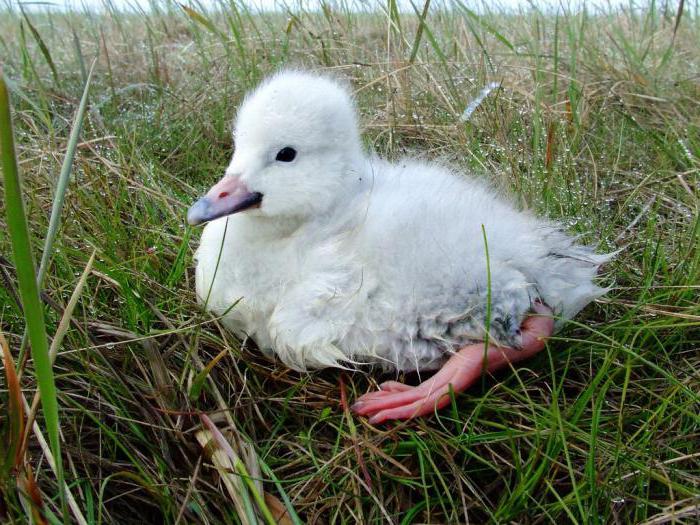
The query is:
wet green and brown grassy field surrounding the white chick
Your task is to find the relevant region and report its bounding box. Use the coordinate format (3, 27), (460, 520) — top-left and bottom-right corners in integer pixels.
(0, 1), (700, 525)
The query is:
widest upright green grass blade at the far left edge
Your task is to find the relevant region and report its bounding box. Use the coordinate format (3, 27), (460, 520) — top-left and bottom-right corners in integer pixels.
(0, 67), (67, 517)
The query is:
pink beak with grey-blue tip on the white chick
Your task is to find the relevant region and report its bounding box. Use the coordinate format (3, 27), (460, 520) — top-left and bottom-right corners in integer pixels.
(187, 175), (262, 225)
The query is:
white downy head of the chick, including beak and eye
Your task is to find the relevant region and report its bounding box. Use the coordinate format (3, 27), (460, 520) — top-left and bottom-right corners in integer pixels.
(187, 71), (362, 224)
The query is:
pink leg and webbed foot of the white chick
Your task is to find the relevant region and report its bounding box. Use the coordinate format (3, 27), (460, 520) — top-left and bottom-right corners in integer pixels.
(352, 303), (554, 424)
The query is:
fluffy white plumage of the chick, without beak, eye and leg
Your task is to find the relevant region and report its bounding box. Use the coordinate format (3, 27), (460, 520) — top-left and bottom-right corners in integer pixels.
(196, 71), (610, 370)
